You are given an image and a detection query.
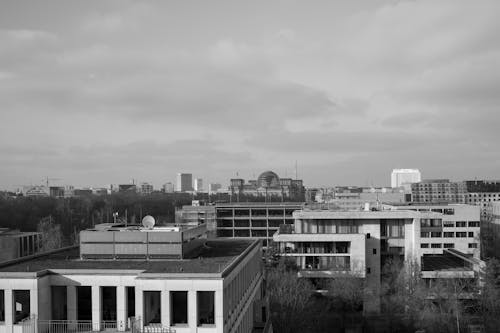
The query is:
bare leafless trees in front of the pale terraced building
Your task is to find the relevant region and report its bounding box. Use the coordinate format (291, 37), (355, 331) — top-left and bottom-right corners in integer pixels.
(267, 259), (500, 333)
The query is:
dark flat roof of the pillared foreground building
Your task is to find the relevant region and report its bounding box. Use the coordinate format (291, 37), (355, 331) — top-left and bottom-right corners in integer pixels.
(0, 239), (260, 278)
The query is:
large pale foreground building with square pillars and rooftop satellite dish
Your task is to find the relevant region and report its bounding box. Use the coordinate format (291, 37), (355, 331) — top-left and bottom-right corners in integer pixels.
(0, 220), (272, 333)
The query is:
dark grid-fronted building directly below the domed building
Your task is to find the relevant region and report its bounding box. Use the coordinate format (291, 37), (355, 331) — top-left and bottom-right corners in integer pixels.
(215, 202), (302, 246)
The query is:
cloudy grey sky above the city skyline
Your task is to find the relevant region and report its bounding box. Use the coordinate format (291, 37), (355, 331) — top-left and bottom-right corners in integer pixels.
(0, 0), (500, 189)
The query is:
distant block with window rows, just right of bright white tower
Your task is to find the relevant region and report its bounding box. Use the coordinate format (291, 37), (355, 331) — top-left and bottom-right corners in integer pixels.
(411, 179), (467, 203)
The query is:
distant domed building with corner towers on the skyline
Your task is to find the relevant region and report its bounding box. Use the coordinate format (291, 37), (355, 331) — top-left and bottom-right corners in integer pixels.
(229, 171), (305, 202)
